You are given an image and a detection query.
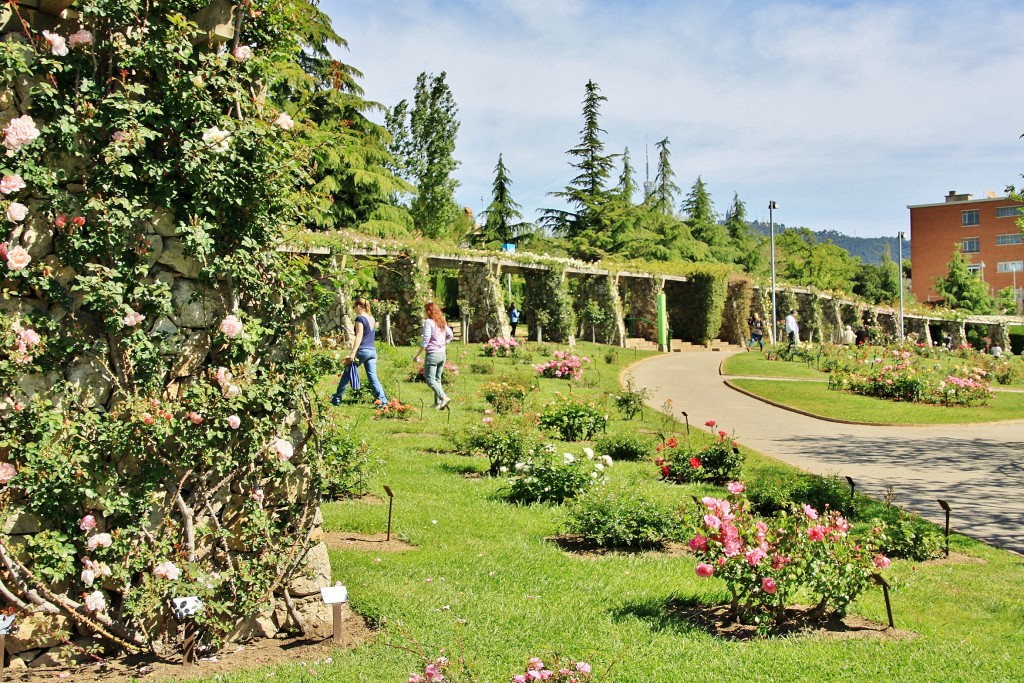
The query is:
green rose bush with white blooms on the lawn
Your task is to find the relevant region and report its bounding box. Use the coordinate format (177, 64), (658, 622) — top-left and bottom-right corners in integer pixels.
(508, 445), (611, 504)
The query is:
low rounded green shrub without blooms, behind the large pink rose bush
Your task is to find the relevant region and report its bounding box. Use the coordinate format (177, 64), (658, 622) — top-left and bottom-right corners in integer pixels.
(565, 488), (683, 548)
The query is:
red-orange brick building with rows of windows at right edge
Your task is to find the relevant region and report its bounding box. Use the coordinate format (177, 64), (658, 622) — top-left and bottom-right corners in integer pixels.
(907, 191), (1024, 301)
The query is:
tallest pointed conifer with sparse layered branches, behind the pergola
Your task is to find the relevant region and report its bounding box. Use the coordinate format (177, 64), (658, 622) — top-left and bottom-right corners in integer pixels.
(541, 81), (614, 249)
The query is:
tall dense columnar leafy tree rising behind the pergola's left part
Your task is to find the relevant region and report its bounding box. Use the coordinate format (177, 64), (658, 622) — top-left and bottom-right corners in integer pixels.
(386, 72), (460, 238)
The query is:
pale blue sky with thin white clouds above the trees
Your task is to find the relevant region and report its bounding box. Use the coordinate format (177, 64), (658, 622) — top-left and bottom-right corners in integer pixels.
(321, 0), (1024, 237)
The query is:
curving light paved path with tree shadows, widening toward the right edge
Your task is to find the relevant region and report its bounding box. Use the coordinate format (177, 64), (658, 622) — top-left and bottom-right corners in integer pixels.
(630, 352), (1024, 553)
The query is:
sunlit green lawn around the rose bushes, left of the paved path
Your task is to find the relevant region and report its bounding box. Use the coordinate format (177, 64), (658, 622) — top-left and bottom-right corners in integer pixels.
(199, 344), (1024, 683)
